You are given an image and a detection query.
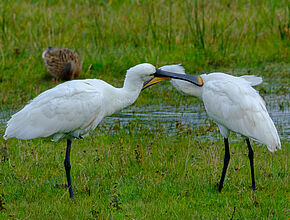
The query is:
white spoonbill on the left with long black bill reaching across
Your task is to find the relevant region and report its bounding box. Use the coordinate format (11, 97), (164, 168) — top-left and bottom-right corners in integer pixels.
(4, 63), (200, 198)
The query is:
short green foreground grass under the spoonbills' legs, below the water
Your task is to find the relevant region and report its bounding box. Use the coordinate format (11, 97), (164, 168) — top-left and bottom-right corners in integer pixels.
(0, 123), (289, 219)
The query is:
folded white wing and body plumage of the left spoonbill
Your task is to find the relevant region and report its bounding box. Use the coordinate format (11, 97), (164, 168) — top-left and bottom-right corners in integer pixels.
(4, 79), (105, 139)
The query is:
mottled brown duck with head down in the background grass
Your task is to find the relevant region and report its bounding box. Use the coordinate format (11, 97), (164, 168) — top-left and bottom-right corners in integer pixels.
(42, 47), (82, 83)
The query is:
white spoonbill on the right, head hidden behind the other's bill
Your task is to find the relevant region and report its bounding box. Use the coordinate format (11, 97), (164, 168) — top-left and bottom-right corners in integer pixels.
(144, 65), (281, 191)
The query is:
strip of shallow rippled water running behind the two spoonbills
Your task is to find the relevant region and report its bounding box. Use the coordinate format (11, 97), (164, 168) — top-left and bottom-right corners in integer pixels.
(0, 95), (290, 141)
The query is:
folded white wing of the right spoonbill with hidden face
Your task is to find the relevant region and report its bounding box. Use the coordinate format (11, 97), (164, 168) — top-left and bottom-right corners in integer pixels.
(202, 78), (281, 151)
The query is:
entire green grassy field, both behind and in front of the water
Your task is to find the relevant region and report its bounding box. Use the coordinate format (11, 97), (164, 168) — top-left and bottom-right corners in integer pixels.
(0, 0), (290, 219)
